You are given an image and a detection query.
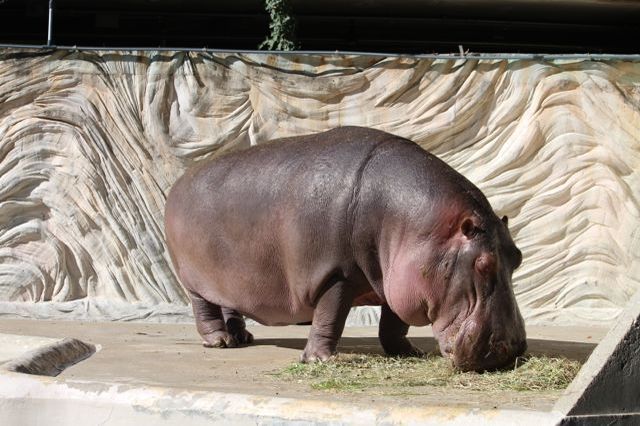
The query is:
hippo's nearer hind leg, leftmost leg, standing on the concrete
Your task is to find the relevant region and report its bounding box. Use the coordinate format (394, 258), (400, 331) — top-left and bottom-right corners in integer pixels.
(189, 291), (238, 348)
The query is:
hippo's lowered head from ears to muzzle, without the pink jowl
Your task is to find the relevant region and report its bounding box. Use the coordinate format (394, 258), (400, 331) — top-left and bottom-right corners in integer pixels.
(433, 216), (527, 371)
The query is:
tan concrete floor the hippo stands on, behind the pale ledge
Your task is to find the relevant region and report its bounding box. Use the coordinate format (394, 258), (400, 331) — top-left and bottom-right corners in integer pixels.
(0, 320), (607, 411)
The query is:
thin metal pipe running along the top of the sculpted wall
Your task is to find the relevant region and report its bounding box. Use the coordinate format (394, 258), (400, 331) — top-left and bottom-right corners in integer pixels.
(0, 43), (640, 61)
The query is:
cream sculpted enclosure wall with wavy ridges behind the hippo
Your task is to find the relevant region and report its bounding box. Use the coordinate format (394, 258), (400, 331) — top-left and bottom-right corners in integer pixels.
(0, 50), (640, 324)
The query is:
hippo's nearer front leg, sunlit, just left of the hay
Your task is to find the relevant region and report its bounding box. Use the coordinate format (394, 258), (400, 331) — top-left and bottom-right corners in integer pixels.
(300, 281), (354, 362)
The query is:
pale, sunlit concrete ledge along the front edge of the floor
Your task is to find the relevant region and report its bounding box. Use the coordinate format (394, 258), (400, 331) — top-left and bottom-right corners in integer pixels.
(0, 372), (562, 426)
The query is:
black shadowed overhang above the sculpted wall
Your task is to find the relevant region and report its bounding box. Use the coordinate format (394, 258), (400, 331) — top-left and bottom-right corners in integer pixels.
(0, 0), (640, 54)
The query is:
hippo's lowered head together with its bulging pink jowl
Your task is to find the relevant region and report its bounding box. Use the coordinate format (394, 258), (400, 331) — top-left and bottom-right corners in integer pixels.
(385, 214), (526, 371)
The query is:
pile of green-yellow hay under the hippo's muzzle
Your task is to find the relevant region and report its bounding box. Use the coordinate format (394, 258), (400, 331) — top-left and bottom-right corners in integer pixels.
(274, 354), (581, 391)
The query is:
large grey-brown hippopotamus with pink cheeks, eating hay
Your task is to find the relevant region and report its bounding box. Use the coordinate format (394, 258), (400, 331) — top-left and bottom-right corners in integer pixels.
(165, 127), (526, 371)
